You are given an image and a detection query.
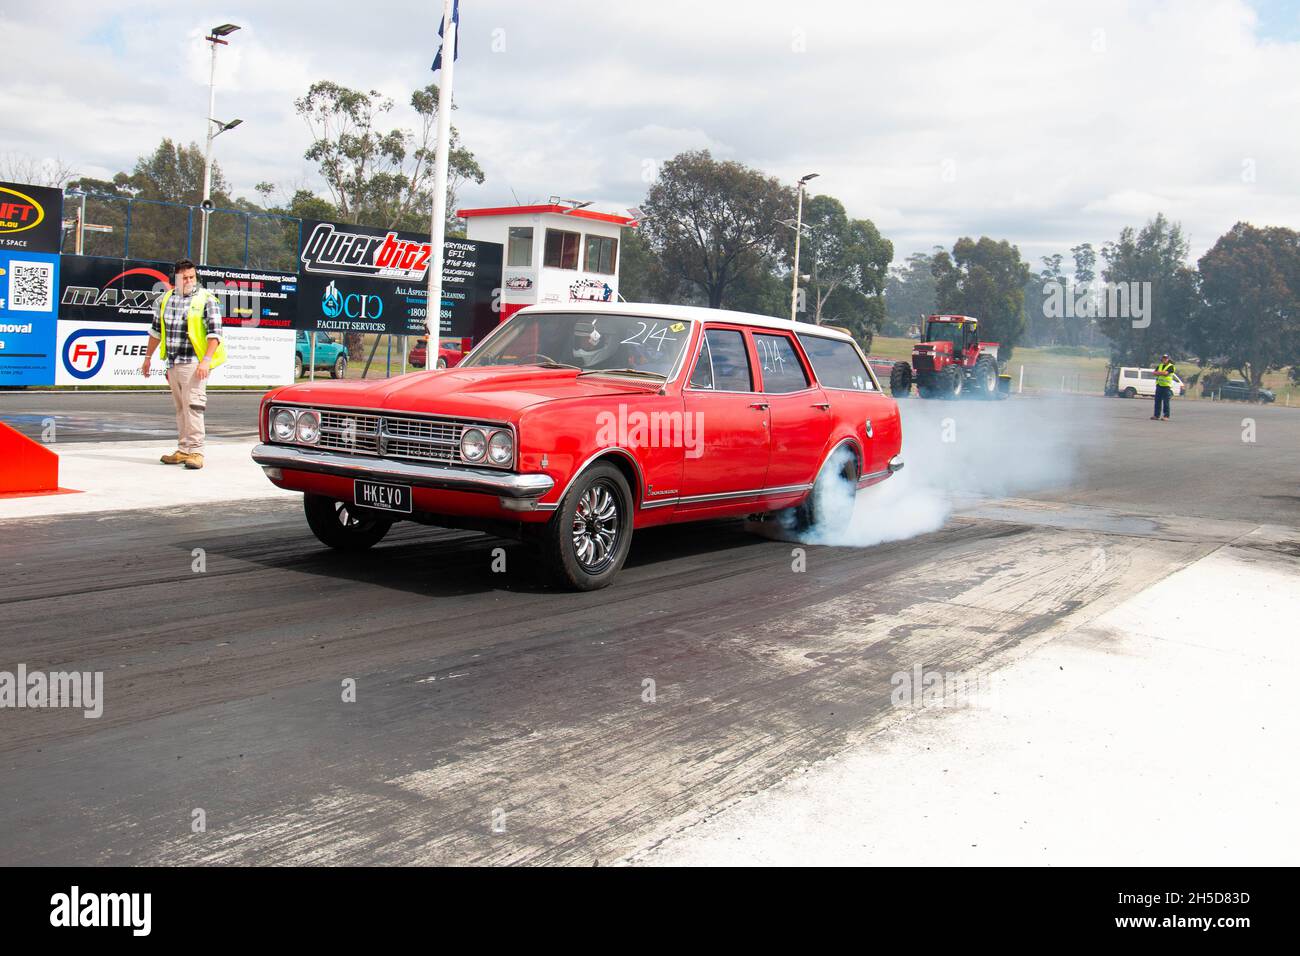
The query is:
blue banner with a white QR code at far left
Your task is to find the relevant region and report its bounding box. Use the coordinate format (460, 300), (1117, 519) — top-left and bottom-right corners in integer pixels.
(0, 248), (59, 385)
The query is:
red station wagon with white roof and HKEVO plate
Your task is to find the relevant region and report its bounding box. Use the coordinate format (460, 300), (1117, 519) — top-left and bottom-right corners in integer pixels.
(252, 303), (902, 591)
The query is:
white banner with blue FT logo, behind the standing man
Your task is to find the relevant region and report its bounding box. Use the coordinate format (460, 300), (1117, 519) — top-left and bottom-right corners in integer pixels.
(55, 320), (296, 388)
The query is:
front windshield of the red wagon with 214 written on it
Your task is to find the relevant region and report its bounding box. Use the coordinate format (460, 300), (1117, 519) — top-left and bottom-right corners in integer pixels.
(460, 312), (690, 378)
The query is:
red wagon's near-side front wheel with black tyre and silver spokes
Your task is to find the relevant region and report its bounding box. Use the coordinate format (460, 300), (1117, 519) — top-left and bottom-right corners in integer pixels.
(541, 462), (632, 591)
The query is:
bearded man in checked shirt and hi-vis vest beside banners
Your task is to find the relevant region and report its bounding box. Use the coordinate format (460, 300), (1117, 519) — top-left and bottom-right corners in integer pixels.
(140, 259), (226, 468)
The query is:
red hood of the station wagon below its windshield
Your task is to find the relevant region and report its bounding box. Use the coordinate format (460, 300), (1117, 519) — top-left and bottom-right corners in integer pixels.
(265, 365), (658, 419)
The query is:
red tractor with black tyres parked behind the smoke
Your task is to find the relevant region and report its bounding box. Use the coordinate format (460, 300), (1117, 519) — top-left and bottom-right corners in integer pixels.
(889, 315), (1000, 398)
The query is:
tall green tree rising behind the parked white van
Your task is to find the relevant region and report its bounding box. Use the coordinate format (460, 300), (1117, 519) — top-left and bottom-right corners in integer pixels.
(1097, 215), (1197, 365)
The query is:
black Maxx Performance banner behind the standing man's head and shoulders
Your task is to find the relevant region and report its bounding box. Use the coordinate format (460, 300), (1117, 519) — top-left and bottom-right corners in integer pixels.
(59, 255), (298, 329)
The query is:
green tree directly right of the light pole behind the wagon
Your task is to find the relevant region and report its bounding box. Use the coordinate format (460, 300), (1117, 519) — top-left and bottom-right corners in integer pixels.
(800, 196), (893, 326)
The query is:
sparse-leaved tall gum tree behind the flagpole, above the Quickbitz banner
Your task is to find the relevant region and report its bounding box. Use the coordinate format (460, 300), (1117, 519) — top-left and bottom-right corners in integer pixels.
(294, 81), (484, 232)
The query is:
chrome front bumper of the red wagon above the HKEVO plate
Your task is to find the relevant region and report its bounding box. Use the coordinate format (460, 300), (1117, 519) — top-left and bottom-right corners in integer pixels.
(252, 445), (555, 498)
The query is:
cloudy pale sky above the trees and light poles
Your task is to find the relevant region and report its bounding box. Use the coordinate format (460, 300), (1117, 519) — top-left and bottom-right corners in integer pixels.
(0, 0), (1300, 264)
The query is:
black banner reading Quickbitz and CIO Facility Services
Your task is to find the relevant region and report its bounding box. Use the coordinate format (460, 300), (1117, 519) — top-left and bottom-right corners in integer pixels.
(298, 221), (502, 341)
